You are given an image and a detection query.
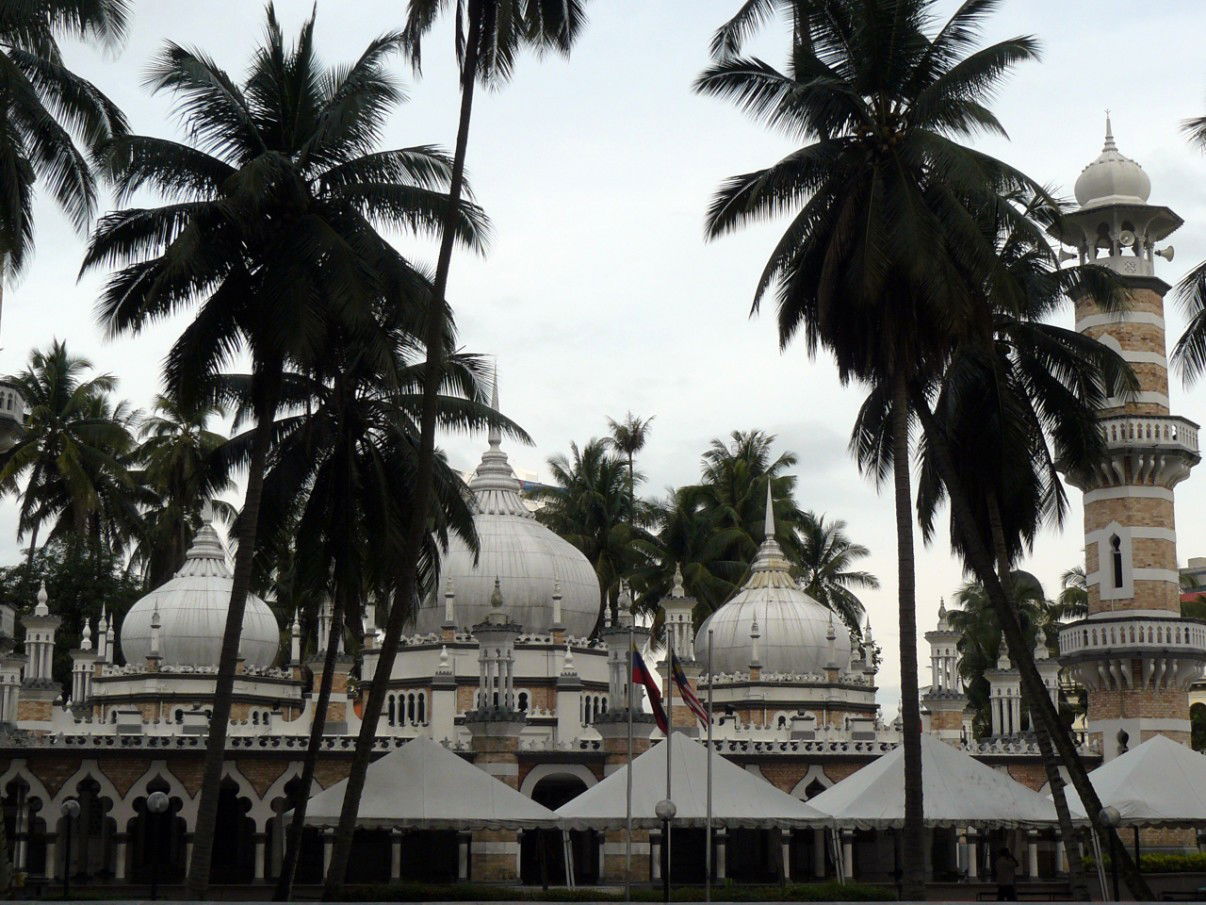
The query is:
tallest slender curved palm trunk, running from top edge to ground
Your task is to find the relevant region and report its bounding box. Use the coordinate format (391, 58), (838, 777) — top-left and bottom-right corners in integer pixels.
(322, 7), (481, 901)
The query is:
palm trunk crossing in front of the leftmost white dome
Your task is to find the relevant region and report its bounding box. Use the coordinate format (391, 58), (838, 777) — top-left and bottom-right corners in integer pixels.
(188, 375), (277, 899)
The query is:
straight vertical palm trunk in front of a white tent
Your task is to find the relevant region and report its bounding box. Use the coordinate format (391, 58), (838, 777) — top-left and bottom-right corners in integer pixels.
(892, 372), (925, 901)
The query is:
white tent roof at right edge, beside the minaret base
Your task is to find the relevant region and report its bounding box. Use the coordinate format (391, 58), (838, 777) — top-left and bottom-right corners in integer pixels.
(1066, 735), (1206, 827)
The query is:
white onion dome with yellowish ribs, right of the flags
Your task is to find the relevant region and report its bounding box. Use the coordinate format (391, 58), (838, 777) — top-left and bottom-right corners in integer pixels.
(695, 486), (850, 675)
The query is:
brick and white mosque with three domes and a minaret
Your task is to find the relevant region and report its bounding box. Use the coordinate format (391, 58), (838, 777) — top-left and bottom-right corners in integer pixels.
(0, 122), (1206, 883)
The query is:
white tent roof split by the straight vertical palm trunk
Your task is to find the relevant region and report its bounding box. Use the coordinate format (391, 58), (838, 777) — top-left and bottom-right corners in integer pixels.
(808, 735), (1055, 829)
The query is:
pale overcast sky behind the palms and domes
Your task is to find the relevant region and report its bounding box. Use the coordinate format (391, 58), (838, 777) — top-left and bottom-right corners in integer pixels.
(0, 0), (1206, 718)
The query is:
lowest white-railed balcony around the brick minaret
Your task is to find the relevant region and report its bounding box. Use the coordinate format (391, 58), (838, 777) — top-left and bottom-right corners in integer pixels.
(1059, 613), (1206, 691)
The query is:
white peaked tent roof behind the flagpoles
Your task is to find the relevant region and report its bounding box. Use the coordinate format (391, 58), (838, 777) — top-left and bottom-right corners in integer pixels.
(557, 732), (825, 829)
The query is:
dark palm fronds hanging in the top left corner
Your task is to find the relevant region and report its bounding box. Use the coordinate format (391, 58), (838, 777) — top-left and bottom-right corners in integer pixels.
(0, 0), (129, 323)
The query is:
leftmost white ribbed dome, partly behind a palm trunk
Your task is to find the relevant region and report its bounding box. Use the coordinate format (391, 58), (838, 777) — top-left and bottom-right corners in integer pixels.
(122, 524), (281, 668)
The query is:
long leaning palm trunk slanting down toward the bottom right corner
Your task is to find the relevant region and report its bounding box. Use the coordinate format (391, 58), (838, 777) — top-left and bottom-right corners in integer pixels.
(913, 393), (1154, 901)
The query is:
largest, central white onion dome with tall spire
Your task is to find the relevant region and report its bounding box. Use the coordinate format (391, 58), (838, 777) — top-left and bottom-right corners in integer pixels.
(415, 376), (599, 637)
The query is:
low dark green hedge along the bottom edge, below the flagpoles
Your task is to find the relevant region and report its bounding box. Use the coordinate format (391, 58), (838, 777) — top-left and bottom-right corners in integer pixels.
(343, 882), (896, 901)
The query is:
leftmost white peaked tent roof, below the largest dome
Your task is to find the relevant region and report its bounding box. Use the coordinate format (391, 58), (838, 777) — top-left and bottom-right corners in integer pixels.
(305, 737), (557, 829)
